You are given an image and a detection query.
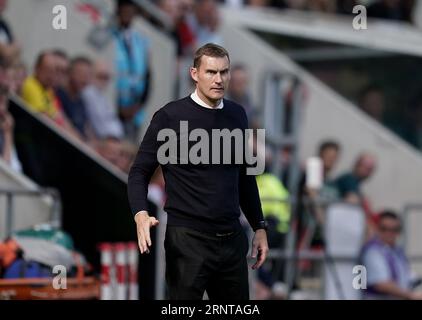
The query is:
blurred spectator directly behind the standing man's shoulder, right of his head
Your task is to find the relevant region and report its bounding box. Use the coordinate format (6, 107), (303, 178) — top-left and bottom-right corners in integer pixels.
(227, 64), (256, 120)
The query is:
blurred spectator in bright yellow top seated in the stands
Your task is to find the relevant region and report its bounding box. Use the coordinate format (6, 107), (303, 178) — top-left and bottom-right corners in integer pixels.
(21, 51), (79, 138)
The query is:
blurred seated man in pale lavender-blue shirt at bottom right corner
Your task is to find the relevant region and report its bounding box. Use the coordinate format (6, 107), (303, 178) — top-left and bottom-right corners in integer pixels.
(361, 211), (422, 300)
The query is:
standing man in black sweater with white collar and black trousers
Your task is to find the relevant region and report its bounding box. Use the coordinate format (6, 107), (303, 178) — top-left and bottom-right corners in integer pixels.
(128, 44), (268, 300)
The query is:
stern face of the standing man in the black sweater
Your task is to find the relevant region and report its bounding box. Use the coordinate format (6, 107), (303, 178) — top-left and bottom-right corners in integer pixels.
(190, 56), (230, 105)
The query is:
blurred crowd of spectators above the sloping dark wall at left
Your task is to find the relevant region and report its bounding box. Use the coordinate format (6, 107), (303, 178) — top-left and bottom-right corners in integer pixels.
(0, 0), (143, 172)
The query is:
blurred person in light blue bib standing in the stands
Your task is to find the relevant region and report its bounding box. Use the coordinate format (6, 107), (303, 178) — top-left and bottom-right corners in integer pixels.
(115, 0), (150, 141)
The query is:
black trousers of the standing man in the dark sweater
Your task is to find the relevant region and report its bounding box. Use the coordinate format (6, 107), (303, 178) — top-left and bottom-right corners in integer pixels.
(164, 226), (249, 300)
